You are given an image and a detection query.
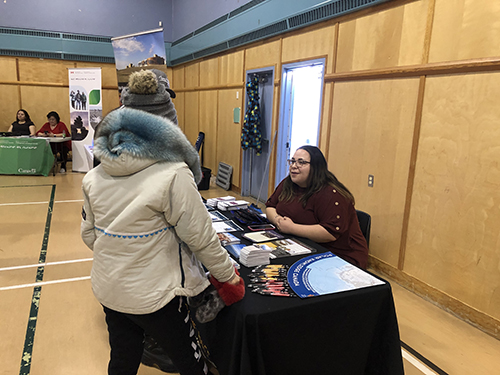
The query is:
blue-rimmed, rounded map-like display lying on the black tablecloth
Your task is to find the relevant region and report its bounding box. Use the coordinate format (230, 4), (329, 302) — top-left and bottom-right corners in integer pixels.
(287, 252), (384, 298)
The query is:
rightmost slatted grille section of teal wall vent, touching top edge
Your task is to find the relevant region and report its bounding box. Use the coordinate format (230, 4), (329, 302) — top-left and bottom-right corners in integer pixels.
(288, 0), (380, 28)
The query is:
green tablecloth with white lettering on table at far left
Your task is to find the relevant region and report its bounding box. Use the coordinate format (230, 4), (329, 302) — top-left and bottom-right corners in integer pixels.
(0, 137), (54, 176)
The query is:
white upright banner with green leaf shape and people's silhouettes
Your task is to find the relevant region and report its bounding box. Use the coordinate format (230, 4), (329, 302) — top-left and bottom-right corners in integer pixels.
(68, 68), (102, 172)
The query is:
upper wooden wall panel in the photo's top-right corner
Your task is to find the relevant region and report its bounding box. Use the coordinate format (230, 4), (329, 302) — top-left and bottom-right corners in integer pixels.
(429, 0), (500, 62)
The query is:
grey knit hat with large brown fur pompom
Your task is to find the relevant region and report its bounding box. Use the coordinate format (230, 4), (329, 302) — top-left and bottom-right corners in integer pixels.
(121, 69), (179, 125)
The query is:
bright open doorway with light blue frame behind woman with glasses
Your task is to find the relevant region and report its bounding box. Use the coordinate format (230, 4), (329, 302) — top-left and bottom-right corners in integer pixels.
(274, 59), (325, 187)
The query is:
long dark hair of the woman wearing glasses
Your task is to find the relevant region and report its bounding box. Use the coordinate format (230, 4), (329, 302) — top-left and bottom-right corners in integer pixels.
(279, 145), (355, 207)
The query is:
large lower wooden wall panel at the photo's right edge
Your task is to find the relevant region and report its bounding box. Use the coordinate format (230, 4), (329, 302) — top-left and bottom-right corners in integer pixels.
(404, 73), (500, 319)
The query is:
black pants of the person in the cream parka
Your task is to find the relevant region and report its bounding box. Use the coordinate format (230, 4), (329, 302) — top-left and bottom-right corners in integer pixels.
(104, 297), (208, 375)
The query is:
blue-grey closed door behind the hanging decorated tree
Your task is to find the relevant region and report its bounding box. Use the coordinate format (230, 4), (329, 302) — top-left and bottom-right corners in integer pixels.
(241, 67), (276, 205)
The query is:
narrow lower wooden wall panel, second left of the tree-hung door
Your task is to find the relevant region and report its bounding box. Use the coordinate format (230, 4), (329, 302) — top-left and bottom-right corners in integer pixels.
(199, 90), (218, 174)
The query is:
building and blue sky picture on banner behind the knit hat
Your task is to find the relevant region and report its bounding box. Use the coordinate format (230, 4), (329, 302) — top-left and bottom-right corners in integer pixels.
(111, 28), (167, 93)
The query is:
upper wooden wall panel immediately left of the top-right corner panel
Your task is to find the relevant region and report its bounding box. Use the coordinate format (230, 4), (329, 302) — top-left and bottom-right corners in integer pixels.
(336, 0), (429, 72)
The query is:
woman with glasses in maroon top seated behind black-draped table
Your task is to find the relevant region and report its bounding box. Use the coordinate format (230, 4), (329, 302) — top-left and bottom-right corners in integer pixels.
(266, 146), (368, 269)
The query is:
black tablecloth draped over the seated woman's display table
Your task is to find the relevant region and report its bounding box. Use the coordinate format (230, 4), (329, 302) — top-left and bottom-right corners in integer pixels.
(198, 209), (404, 375)
